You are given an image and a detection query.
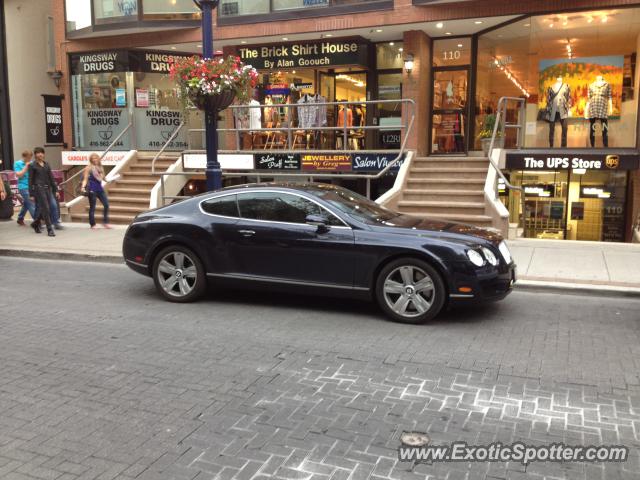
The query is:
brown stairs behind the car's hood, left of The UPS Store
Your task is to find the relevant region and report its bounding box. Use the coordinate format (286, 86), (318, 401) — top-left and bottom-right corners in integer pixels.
(397, 157), (492, 227)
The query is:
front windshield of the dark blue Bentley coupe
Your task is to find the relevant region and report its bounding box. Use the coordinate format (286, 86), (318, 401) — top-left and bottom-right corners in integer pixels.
(313, 186), (401, 225)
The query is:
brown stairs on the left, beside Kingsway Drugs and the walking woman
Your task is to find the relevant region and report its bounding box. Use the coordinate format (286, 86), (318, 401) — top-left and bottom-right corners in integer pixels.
(71, 152), (178, 225)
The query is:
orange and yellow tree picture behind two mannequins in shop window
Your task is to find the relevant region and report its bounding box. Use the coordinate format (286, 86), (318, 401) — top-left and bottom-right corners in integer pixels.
(538, 55), (624, 118)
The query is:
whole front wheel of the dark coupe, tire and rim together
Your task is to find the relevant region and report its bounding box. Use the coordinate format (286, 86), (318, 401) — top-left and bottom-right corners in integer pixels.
(376, 257), (446, 324)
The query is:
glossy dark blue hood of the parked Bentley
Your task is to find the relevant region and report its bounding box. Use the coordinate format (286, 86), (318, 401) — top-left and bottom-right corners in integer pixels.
(374, 215), (503, 245)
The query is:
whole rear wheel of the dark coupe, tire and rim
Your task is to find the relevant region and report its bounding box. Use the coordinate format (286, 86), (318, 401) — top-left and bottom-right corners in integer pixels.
(152, 245), (207, 303)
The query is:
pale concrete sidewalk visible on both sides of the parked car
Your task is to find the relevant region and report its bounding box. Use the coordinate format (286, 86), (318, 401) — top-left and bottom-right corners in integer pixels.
(0, 220), (640, 295)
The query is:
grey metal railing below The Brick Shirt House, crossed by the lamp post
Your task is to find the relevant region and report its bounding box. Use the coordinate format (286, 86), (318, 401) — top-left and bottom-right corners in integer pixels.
(152, 99), (415, 204)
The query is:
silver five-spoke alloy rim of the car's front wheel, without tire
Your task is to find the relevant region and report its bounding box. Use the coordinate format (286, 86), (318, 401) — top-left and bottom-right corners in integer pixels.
(383, 265), (435, 318)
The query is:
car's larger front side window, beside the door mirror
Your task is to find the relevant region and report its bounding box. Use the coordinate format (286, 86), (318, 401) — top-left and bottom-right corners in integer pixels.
(238, 192), (343, 226)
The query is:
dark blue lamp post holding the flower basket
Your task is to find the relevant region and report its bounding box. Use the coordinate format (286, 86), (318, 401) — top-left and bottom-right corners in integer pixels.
(193, 0), (222, 191)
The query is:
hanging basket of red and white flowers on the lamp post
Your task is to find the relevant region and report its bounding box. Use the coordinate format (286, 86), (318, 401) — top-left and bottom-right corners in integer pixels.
(169, 56), (258, 112)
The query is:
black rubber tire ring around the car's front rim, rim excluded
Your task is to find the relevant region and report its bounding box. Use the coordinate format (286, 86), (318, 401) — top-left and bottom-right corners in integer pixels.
(376, 257), (447, 325)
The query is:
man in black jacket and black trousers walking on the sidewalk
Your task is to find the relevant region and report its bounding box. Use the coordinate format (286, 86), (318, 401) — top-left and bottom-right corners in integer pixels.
(29, 147), (57, 237)
